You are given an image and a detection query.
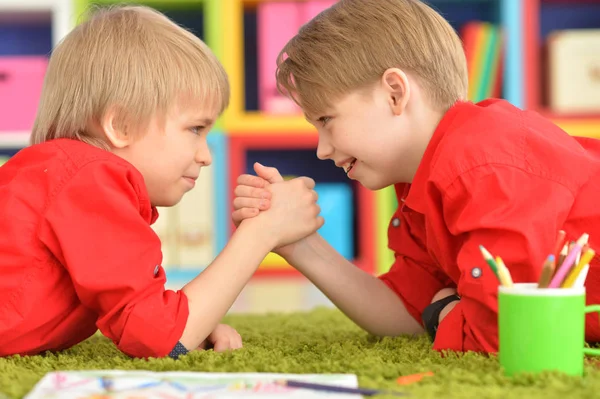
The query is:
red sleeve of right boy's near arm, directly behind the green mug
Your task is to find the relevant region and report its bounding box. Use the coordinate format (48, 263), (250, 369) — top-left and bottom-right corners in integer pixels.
(434, 165), (583, 352)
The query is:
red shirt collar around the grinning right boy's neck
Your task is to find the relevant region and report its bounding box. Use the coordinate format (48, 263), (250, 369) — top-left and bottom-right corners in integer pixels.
(404, 101), (472, 214)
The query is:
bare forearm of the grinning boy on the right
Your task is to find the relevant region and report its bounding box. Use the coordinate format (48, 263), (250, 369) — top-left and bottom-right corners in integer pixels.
(287, 234), (423, 336)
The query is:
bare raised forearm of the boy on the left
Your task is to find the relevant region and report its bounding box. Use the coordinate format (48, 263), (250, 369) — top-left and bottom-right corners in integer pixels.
(180, 222), (273, 349)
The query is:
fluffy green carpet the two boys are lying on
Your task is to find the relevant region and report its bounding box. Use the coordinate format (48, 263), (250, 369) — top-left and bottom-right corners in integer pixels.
(0, 309), (600, 399)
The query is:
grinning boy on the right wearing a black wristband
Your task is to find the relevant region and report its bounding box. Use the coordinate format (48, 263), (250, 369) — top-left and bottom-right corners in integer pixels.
(233, 0), (600, 352)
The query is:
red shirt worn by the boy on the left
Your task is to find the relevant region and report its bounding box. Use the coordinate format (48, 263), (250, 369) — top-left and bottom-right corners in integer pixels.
(0, 139), (188, 357)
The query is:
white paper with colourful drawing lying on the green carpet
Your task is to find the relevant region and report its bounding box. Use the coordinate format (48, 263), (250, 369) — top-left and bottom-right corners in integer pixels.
(25, 370), (360, 399)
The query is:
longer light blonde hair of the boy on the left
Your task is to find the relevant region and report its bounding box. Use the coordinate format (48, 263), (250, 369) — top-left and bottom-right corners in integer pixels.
(31, 6), (229, 149)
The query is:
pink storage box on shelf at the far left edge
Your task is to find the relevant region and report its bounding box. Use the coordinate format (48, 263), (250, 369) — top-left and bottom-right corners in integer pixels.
(0, 56), (48, 134)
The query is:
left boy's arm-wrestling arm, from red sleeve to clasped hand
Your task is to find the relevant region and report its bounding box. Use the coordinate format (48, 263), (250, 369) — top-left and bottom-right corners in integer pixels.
(40, 163), (320, 357)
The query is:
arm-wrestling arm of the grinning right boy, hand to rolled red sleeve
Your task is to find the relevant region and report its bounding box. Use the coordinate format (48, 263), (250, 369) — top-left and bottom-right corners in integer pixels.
(232, 165), (452, 335)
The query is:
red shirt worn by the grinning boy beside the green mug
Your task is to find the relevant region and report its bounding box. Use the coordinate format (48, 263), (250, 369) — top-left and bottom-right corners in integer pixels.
(381, 100), (600, 352)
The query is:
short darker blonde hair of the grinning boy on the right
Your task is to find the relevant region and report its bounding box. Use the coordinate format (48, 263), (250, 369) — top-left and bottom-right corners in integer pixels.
(277, 0), (468, 117)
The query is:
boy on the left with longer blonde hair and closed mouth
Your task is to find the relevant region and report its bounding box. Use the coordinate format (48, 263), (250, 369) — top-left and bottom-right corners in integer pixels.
(0, 3), (323, 358)
